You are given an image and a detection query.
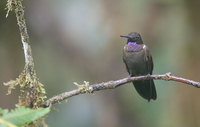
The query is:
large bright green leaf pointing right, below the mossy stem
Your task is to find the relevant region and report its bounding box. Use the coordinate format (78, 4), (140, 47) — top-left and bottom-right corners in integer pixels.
(0, 107), (50, 126)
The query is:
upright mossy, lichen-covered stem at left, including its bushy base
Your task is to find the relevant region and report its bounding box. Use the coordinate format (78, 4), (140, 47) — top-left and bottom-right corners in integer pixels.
(4, 0), (46, 109)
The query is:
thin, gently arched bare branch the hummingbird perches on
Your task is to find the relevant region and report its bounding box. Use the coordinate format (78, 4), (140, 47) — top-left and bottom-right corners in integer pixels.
(43, 73), (200, 107)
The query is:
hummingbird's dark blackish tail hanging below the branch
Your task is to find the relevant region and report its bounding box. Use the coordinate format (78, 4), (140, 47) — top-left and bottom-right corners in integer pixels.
(133, 79), (157, 101)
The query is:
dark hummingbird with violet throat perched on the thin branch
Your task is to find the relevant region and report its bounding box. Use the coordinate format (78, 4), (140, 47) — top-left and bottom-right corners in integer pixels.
(120, 32), (157, 101)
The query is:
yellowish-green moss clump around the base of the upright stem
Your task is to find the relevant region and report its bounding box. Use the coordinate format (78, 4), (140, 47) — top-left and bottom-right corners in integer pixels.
(4, 73), (46, 109)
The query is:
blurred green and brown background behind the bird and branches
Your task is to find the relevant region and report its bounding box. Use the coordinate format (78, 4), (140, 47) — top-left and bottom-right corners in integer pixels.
(0, 0), (200, 127)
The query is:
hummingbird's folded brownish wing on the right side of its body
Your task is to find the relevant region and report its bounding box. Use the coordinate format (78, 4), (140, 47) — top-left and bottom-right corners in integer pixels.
(143, 45), (153, 74)
